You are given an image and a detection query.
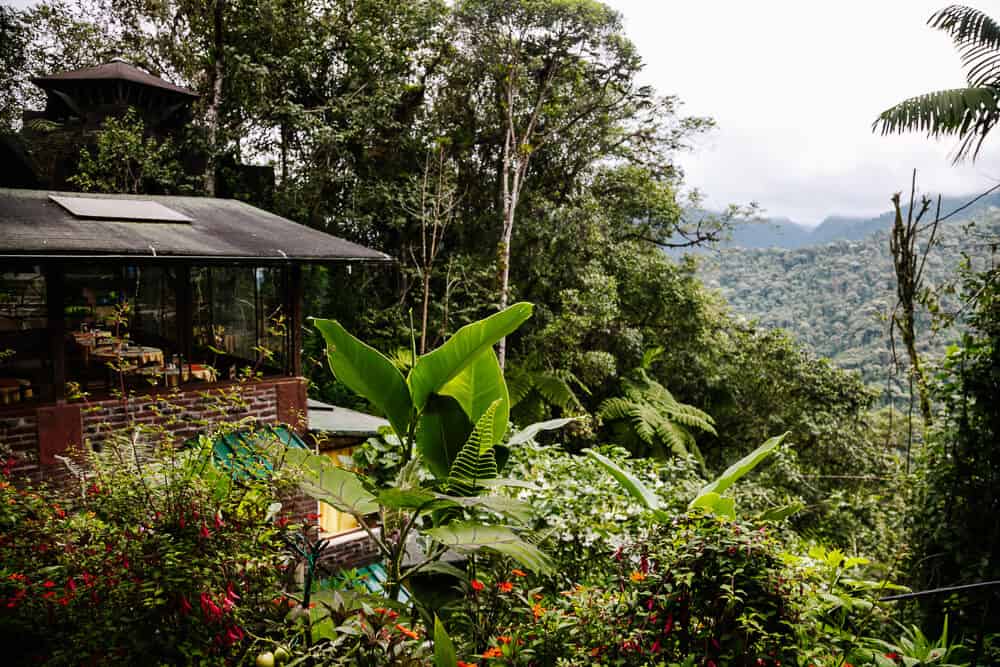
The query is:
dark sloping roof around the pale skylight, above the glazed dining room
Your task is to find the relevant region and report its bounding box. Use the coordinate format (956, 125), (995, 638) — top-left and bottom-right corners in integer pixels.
(0, 188), (391, 262)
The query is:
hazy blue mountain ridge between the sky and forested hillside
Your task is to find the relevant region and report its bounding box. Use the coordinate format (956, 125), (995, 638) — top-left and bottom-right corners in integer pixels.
(720, 191), (1000, 249)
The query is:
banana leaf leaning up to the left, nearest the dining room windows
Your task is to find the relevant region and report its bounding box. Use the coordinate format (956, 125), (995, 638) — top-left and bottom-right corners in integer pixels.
(313, 319), (413, 438)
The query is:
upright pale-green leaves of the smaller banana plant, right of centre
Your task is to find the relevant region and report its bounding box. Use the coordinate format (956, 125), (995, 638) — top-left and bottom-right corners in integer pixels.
(583, 433), (795, 523)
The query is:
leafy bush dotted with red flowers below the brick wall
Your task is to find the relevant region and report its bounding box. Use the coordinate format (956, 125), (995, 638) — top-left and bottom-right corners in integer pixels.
(0, 440), (287, 665)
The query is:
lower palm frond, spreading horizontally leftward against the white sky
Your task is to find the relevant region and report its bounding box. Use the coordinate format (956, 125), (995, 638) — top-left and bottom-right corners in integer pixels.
(872, 86), (1000, 162)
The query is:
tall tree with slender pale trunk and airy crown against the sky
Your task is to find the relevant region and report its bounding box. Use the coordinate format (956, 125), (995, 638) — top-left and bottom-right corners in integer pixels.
(456, 0), (655, 366)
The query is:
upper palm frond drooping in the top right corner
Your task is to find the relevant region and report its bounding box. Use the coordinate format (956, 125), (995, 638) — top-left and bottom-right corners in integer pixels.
(927, 5), (1000, 88)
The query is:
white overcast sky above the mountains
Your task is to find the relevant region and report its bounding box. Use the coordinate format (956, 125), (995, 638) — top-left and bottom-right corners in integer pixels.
(608, 0), (1000, 224)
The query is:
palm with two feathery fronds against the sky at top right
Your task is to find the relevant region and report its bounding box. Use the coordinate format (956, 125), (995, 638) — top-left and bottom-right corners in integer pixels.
(872, 5), (1000, 162)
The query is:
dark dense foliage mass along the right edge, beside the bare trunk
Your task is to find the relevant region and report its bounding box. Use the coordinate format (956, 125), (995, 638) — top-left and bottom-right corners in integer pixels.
(908, 269), (1000, 632)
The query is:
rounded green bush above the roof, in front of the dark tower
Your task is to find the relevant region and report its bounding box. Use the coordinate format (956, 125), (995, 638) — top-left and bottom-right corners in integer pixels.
(68, 109), (186, 194)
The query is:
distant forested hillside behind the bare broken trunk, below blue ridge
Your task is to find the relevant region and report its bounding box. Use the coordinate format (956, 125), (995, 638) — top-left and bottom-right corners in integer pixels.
(699, 209), (1000, 392)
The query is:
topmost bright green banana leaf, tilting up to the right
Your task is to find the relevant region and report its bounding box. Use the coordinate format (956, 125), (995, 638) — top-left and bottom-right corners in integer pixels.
(407, 303), (533, 411)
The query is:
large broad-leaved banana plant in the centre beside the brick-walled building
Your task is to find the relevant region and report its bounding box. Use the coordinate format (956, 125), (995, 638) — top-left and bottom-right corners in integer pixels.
(285, 303), (572, 599)
